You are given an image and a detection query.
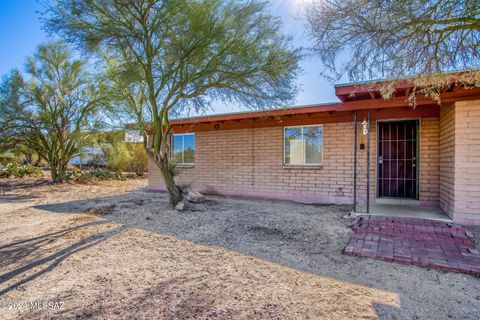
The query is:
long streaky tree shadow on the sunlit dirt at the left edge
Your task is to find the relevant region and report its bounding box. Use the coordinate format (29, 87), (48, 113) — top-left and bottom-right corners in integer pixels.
(0, 221), (127, 296)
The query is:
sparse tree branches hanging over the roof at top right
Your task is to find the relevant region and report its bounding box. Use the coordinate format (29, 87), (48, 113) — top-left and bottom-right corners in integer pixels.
(305, 0), (480, 100)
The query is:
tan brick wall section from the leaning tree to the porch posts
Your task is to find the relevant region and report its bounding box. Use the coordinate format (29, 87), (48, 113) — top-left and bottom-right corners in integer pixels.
(149, 123), (360, 204)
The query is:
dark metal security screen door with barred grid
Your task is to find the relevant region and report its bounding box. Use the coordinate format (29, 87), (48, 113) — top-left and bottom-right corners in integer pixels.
(377, 120), (418, 199)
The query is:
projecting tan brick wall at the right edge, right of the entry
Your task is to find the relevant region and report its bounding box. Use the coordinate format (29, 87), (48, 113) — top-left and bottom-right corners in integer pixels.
(440, 100), (480, 225)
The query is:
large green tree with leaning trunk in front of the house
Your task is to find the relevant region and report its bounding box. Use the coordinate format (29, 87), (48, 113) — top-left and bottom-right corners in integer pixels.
(46, 0), (299, 204)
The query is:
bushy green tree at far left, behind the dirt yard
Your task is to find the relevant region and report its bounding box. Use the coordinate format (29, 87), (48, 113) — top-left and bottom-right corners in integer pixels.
(0, 42), (106, 182)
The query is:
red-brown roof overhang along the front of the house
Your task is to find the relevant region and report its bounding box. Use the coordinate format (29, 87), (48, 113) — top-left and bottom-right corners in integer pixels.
(127, 81), (480, 132)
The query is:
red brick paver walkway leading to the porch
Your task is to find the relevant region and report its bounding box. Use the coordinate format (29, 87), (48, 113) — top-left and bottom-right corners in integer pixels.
(344, 216), (480, 276)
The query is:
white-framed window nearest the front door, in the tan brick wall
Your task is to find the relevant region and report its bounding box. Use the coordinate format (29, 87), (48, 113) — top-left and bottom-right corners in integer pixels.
(283, 125), (323, 165)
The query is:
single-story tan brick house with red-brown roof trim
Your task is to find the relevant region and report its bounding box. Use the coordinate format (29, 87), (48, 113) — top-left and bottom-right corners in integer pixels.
(148, 77), (480, 224)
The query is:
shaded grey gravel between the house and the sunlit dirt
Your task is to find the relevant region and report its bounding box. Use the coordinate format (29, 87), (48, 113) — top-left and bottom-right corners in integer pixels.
(0, 179), (480, 319)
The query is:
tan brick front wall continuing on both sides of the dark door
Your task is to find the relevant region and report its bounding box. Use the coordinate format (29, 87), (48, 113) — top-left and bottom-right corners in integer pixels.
(149, 118), (440, 210)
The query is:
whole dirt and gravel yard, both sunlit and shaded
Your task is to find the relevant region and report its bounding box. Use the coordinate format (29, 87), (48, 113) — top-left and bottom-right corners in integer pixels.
(0, 180), (480, 319)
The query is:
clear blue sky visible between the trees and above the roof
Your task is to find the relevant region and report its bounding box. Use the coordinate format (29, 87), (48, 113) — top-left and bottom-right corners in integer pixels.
(0, 0), (344, 113)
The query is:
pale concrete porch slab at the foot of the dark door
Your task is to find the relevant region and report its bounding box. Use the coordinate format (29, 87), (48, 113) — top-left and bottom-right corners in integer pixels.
(369, 203), (452, 222)
